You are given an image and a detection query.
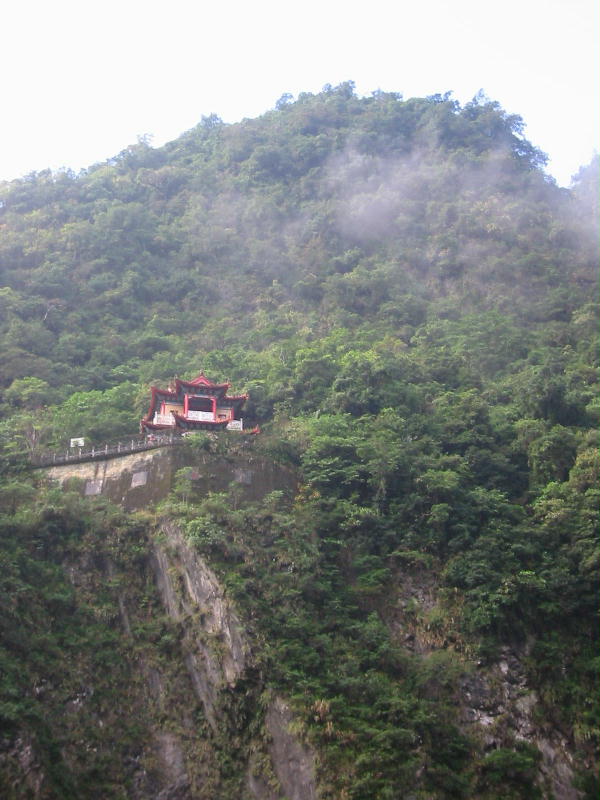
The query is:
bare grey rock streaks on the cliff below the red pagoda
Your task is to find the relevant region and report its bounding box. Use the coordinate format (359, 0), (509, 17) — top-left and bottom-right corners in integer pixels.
(152, 522), (317, 800)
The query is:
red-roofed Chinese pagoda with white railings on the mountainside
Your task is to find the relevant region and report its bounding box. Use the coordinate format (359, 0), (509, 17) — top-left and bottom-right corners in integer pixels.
(140, 372), (248, 433)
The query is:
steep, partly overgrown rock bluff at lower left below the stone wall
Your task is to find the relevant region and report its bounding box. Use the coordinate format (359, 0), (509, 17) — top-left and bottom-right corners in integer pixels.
(0, 494), (315, 800)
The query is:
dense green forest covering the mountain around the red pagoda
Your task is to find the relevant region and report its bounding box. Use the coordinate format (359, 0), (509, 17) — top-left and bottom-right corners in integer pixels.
(0, 83), (600, 800)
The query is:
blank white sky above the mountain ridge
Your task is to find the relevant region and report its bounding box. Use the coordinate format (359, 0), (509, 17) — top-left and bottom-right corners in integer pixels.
(0, 0), (600, 185)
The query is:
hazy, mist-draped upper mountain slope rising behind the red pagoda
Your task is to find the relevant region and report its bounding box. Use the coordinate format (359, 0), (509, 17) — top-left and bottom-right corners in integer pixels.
(0, 90), (593, 410)
